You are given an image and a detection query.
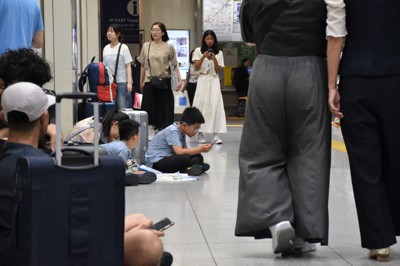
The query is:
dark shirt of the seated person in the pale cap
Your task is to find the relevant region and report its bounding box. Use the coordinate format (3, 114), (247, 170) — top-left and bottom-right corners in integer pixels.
(0, 142), (48, 266)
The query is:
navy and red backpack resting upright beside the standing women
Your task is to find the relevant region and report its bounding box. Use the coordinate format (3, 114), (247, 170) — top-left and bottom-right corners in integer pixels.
(78, 57), (117, 102)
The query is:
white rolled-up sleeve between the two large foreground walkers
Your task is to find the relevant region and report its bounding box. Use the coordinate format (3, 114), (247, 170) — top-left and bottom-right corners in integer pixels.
(325, 0), (347, 37)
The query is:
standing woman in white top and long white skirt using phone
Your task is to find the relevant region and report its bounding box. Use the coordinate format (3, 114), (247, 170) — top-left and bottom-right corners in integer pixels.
(193, 30), (226, 144)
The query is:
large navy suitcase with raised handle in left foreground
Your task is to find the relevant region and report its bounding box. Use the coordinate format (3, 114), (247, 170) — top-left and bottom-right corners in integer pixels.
(12, 93), (125, 266)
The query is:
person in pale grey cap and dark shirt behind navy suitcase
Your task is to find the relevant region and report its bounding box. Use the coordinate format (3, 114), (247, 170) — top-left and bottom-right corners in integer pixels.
(0, 82), (49, 266)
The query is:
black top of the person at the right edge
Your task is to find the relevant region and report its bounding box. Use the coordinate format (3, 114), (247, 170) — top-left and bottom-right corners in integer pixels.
(339, 0), (400, 76)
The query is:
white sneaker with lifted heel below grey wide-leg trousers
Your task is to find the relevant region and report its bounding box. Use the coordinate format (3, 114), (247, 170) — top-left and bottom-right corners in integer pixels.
(269, 221), (295, 254)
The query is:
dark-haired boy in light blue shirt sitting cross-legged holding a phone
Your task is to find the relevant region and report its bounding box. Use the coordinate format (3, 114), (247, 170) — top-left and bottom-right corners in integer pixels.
(146, 107), (213, 176)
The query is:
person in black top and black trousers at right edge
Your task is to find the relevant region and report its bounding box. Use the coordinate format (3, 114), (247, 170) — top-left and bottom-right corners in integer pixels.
(329, 0), (400, 261)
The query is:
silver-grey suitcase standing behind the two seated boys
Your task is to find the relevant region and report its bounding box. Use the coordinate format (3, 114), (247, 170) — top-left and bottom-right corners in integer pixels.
(120, 108), (149, 164)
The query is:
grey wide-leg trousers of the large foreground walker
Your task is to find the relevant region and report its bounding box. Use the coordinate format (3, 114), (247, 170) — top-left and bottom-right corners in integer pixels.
(235, 54), (331, 244)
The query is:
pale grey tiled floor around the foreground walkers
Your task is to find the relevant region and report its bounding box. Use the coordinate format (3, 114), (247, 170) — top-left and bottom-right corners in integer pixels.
(126, 120), (400, 266)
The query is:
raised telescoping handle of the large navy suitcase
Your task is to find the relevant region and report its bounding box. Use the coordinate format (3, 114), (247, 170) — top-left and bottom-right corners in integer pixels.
(56, 92), (100, 166)
